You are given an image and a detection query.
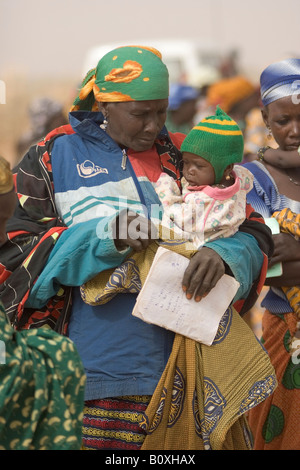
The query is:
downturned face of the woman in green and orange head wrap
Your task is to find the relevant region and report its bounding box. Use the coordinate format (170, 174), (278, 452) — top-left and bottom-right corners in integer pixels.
(99, 99), (168, 152)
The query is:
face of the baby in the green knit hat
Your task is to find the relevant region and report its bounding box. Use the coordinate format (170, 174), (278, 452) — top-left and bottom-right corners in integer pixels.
(182, 152), (215, 186)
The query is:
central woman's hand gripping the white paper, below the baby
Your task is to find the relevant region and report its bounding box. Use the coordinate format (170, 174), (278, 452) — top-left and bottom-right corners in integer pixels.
(182, 247), (225, 302)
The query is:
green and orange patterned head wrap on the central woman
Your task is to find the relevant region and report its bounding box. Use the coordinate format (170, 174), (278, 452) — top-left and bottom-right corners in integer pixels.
(72, 46), (169, 111)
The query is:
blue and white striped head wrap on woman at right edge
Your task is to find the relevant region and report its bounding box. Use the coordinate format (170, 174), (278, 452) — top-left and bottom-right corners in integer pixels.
(260, 59), (300, 106)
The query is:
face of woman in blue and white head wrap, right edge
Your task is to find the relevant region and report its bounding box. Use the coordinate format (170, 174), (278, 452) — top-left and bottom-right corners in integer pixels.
(262, 96), (300, 151)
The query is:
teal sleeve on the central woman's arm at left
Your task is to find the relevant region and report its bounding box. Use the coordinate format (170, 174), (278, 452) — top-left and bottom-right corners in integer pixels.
(26, 215), (130, 308)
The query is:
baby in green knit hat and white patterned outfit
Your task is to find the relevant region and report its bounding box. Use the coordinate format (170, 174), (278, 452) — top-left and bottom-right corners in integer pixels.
(155, 107), (253, 247)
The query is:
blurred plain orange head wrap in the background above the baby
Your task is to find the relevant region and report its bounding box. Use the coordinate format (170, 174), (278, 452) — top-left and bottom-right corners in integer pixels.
(207, 76), (256, 113)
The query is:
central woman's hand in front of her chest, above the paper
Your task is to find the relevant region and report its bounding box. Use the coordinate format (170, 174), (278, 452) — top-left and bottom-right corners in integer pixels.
(115, 210), (158, 251)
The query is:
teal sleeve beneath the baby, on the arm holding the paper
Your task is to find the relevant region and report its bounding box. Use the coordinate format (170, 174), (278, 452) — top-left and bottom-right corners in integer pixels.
(205, 232), (264, 303)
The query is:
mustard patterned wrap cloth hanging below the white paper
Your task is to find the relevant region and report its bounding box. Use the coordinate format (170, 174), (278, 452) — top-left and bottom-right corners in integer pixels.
(141, 307), (277, 450)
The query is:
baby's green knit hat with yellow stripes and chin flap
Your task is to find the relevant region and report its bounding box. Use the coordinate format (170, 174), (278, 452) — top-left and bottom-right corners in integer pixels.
(180, 106), (244, 184)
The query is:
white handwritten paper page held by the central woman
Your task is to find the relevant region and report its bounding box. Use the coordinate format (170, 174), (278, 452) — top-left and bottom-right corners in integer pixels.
(133, 247), (239, 345)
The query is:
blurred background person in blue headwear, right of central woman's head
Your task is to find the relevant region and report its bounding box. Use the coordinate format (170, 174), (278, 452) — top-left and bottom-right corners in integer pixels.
(166, 83), (199, 134)
